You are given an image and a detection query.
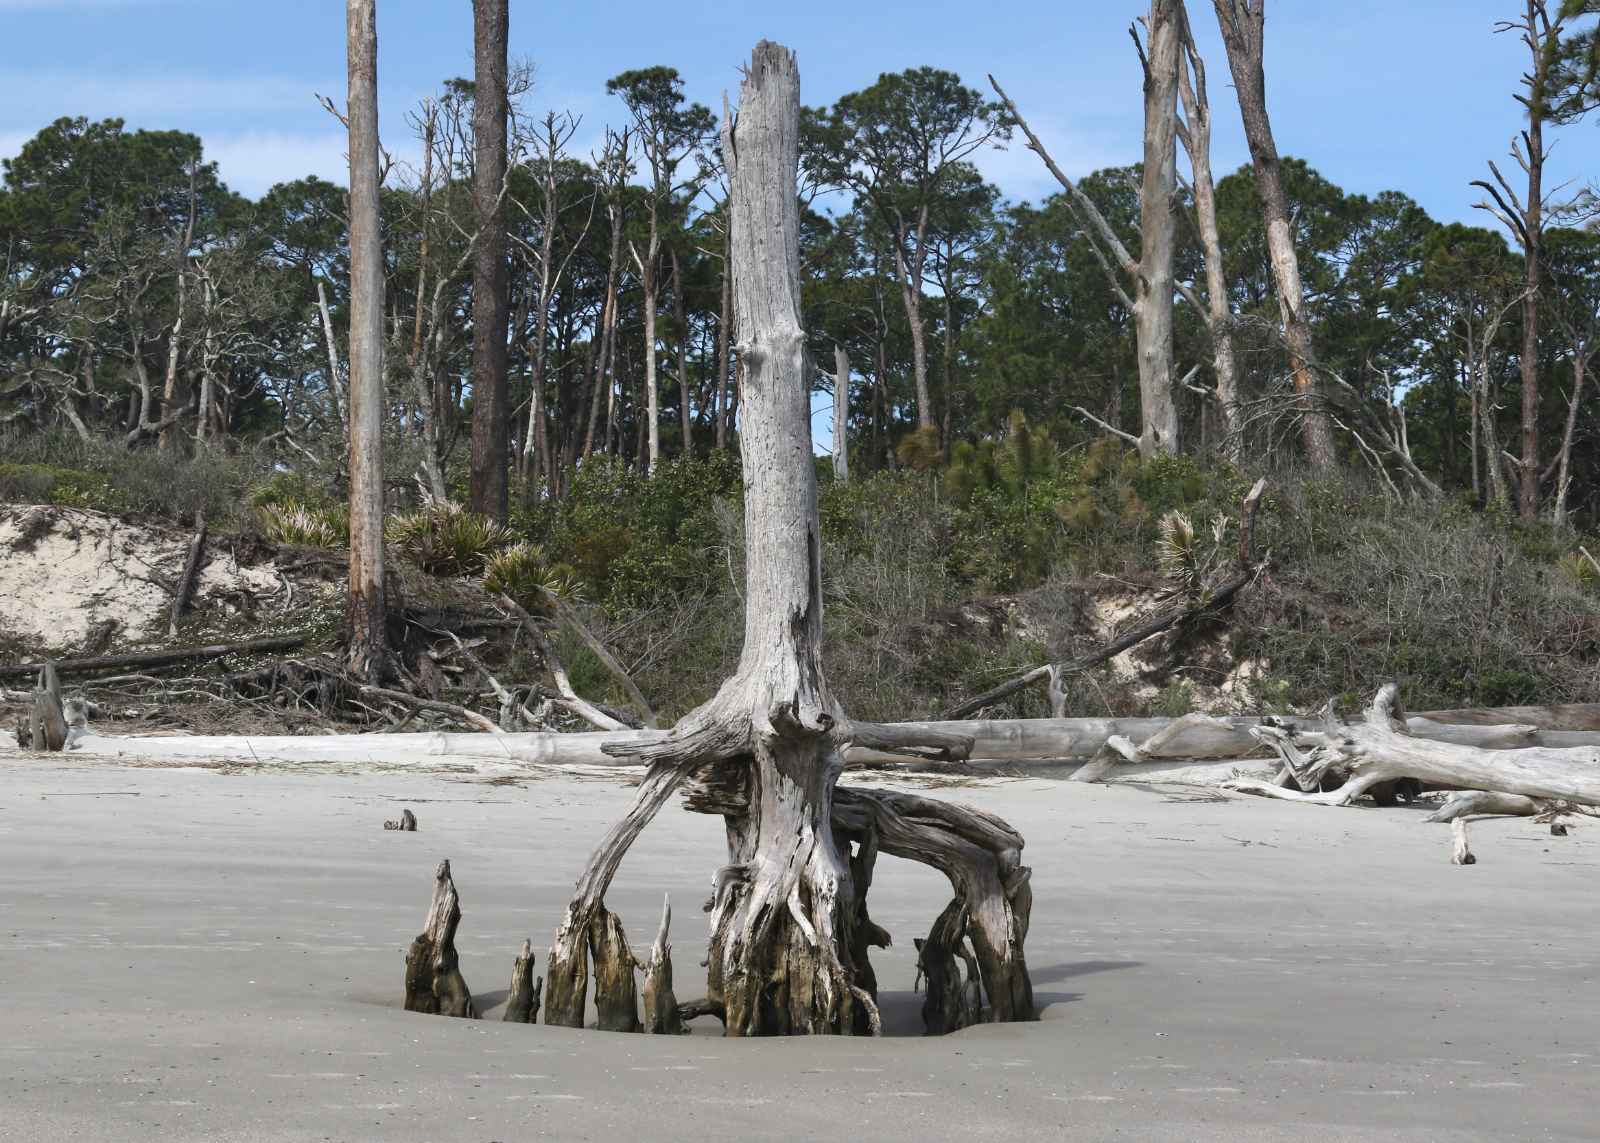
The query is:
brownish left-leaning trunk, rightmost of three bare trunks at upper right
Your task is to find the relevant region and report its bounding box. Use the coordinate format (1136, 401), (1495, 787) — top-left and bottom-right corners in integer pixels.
(1216, 0), (1334, 469)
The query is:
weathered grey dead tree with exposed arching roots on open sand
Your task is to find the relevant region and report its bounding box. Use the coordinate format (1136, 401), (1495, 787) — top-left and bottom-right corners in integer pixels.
(544, 42), (1034, 1036)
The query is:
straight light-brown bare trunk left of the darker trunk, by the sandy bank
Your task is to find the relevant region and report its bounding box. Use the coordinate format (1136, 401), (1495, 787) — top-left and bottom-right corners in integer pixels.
(346, 0), (389, 684)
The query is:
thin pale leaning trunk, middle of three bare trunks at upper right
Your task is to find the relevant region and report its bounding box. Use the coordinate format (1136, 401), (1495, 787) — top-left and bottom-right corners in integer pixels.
(1178, 2), (1245, 463)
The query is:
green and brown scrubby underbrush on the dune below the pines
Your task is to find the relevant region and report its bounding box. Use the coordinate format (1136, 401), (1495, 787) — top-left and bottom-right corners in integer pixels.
(0, 416), (1600, 719)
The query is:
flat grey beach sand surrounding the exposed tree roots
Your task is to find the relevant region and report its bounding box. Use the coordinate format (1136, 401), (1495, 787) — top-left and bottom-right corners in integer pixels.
(0, 757), (1600, 1143)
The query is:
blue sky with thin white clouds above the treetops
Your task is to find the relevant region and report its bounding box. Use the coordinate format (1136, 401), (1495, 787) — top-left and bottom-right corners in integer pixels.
(0, 0), (1600, 223)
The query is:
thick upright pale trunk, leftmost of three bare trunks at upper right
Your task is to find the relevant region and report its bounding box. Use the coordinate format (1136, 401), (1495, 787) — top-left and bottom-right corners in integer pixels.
(1134, 0), (1182, 456)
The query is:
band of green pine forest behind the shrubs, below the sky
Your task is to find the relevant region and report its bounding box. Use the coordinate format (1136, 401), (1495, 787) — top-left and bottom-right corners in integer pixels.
(0, 0), (1600, 519)
